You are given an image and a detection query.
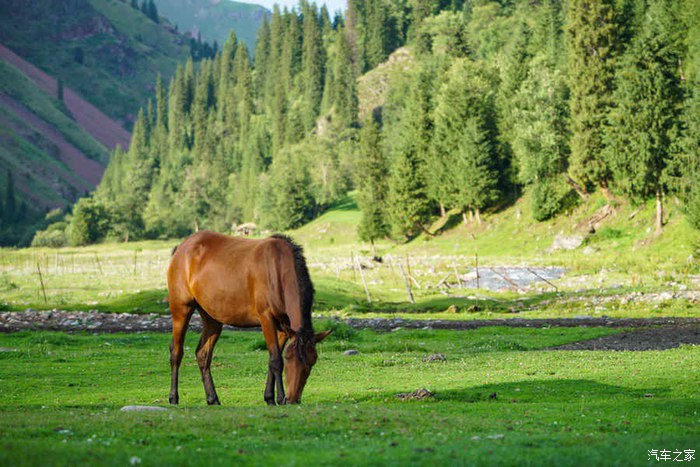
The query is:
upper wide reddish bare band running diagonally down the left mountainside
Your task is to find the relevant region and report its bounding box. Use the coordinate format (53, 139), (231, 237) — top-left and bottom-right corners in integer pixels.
(0, 45), (131, 150)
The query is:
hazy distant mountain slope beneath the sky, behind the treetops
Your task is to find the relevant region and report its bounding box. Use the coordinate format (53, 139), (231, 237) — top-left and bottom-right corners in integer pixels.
(155, 0), (270, 51)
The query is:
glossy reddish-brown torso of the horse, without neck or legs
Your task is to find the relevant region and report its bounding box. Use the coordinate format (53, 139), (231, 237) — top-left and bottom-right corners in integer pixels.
(168, 231), (290, 326)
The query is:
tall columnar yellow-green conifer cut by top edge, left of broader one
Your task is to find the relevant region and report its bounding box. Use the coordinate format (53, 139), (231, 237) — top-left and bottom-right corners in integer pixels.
(567, 0), (617, 196)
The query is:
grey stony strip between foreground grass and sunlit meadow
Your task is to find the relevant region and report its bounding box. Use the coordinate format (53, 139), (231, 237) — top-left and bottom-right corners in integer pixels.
(0, 310), (700, 350)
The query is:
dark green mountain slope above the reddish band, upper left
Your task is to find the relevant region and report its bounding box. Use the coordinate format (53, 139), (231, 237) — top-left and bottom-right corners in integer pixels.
(0, 0), (189, 128)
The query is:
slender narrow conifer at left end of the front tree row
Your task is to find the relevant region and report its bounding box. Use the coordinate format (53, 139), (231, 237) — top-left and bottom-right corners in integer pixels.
(355, 118), (389, 243)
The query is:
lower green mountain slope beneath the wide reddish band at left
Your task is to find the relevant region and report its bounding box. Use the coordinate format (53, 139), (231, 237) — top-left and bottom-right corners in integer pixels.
(0, 62), (107, 211)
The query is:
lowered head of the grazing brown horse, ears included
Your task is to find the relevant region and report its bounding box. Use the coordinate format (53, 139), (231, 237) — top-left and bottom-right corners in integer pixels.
(284, 330), (333, 404)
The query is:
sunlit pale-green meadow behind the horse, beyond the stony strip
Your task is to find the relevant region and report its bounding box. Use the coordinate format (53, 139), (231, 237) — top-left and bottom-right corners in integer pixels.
(0, 192), (700, 319)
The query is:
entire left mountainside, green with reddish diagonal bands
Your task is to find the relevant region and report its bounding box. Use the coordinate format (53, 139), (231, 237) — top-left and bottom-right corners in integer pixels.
(0, 0), (200, 245)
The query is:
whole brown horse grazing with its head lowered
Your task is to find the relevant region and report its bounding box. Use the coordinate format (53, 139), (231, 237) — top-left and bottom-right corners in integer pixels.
(168, 232), (330, 405)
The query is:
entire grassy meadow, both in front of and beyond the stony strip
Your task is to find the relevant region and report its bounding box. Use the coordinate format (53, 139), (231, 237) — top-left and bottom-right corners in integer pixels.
(0, 192), (700, 466)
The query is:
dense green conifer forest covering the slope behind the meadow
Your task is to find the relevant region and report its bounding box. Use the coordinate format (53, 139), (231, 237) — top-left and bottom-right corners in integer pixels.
(34, 0), (700, 249)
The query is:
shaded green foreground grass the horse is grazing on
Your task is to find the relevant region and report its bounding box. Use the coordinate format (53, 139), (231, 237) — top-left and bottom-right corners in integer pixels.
(0, 326), (700, 465)
